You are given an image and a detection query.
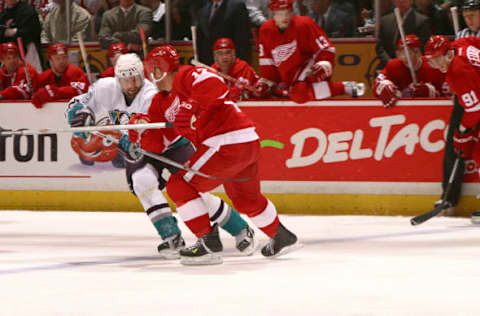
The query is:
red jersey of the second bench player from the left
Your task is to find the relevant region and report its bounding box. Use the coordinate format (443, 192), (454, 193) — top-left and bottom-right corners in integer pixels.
(38, 65), (90, 99)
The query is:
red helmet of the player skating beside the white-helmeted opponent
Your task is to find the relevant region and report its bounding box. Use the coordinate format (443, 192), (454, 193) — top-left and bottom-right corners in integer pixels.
(145, 45), (180, 73)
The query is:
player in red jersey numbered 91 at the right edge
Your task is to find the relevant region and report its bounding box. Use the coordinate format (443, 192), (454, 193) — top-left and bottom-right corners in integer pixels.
(425, 35), (480, 224)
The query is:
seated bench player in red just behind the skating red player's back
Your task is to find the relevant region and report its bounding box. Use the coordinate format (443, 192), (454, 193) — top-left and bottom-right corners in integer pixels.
(212, 37), (259, 101)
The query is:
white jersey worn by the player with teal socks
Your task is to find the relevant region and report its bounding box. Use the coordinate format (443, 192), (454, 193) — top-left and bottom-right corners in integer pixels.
(67, 77), (158, 123)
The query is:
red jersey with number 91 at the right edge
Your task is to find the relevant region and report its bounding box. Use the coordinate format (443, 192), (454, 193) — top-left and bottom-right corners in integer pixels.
(446, 38), (480, 127)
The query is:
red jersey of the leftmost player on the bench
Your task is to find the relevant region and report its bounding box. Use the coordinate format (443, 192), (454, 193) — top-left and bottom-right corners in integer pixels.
(0, 64), (38, 100)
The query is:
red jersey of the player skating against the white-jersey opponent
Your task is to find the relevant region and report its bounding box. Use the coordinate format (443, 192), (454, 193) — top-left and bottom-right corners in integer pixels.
(171, 66), (258, 147)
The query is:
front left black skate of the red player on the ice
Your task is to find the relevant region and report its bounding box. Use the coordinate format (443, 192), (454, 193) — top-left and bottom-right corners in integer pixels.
(180, 224), (223, 265)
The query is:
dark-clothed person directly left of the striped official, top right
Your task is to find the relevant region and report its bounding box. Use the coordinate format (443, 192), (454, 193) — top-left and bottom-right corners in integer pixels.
(415, 0), (453, 35)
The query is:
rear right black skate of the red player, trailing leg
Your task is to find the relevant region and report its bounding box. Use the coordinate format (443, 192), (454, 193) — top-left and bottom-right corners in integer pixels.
(262, 223), (303, 258)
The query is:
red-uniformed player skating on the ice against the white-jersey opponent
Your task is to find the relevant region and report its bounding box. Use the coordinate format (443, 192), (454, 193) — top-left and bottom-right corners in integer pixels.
(142, 45), (299, 264)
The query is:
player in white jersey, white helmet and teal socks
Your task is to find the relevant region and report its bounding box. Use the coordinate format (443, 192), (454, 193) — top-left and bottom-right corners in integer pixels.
(66, 54), (256, 259)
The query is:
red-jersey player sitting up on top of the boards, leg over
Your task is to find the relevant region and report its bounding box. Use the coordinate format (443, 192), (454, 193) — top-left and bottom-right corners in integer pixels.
(257, 0), (365, 103)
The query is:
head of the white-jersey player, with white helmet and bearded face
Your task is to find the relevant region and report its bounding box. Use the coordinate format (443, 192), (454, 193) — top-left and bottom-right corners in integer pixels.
(115, 54), (144, 98)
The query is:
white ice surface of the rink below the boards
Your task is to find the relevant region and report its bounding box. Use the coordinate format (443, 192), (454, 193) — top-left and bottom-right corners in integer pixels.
(0, 211), (480, 316)
